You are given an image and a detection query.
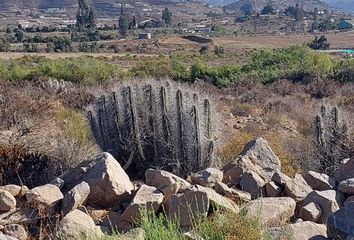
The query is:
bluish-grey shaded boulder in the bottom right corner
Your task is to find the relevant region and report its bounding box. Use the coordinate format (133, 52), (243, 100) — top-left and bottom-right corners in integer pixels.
(327, 203), (354, 240)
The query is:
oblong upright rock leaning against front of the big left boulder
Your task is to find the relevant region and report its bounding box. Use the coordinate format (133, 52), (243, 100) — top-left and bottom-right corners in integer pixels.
(62, 182), (90, 215)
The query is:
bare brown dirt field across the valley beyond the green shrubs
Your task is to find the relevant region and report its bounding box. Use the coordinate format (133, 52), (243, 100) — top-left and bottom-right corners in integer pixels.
(0, 31), (354, 59)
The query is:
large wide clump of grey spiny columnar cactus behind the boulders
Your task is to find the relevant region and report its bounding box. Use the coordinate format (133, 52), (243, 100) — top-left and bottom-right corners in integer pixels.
(88, 81), (214, 177)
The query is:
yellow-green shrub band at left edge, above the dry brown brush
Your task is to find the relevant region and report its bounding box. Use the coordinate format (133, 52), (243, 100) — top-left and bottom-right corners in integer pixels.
(0, 56), (126, 85)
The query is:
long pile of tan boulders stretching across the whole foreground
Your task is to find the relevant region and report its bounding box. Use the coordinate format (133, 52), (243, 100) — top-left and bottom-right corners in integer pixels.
(0, 138), (354, 240)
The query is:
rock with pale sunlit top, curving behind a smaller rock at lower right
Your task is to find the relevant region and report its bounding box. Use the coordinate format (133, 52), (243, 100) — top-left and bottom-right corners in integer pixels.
(302, 190), (342, 223)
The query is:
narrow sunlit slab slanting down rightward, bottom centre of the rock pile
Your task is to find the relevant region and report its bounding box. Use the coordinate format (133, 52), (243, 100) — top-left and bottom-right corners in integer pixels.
(196, 185), (239, 213)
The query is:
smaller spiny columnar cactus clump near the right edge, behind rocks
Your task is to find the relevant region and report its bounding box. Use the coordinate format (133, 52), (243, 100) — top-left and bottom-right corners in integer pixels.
(315, 105), (349, 174)
